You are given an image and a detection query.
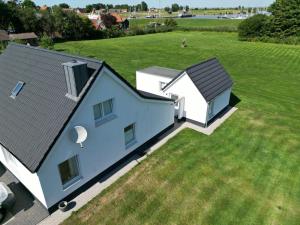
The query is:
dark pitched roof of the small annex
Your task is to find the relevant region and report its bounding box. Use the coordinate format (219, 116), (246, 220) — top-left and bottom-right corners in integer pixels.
(164, 58), (233, 102)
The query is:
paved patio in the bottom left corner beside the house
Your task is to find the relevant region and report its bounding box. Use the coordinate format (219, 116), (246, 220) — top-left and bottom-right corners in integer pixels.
(0, 163), (49, 225)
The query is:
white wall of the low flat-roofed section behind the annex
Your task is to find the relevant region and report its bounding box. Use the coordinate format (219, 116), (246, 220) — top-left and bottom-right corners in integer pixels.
(136, 71), (172, 96)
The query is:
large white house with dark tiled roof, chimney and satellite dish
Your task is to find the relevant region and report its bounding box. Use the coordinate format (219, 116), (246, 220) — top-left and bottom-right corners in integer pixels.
(0, 44), (174, 209)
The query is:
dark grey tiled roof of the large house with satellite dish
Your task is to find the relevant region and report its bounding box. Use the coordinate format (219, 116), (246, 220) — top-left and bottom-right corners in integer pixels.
(0, 44), (171, 172)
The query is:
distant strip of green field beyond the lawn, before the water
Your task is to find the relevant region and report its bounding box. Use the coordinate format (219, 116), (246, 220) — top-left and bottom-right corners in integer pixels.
(130, 18), (241, 29)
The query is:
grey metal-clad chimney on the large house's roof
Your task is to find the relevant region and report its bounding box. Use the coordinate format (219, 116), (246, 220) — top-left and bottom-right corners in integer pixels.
(62, 60), (89, 100)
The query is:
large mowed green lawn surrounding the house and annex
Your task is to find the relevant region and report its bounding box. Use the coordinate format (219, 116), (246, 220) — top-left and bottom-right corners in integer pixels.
(56, 32), (300, 225)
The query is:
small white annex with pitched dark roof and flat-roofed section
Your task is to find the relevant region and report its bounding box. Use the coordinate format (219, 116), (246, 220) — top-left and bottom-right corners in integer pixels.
(136, 58), (233, 126)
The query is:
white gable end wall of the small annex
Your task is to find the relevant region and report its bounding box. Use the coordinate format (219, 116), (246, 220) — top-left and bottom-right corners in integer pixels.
(165, 73), (208, 124)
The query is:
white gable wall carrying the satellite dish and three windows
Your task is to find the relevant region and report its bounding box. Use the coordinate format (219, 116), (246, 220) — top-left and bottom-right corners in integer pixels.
(38, 69), (174, 207)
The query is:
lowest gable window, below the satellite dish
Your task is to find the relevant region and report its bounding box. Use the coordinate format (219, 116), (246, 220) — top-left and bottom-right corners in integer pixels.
(58, 156), (79, 188)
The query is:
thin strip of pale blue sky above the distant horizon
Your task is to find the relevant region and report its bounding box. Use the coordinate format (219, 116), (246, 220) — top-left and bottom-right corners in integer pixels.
(34, 0), (274, 8)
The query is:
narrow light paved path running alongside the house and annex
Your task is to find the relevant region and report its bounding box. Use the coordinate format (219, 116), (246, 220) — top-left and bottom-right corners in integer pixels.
(39, 107), (237, 225)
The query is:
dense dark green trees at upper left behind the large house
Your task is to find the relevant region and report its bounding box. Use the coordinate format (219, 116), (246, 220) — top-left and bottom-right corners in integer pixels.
(0, 0), (94, 39)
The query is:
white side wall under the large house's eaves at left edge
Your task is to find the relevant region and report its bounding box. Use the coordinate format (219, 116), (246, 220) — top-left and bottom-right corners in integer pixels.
(0, 145), (46, 205)
